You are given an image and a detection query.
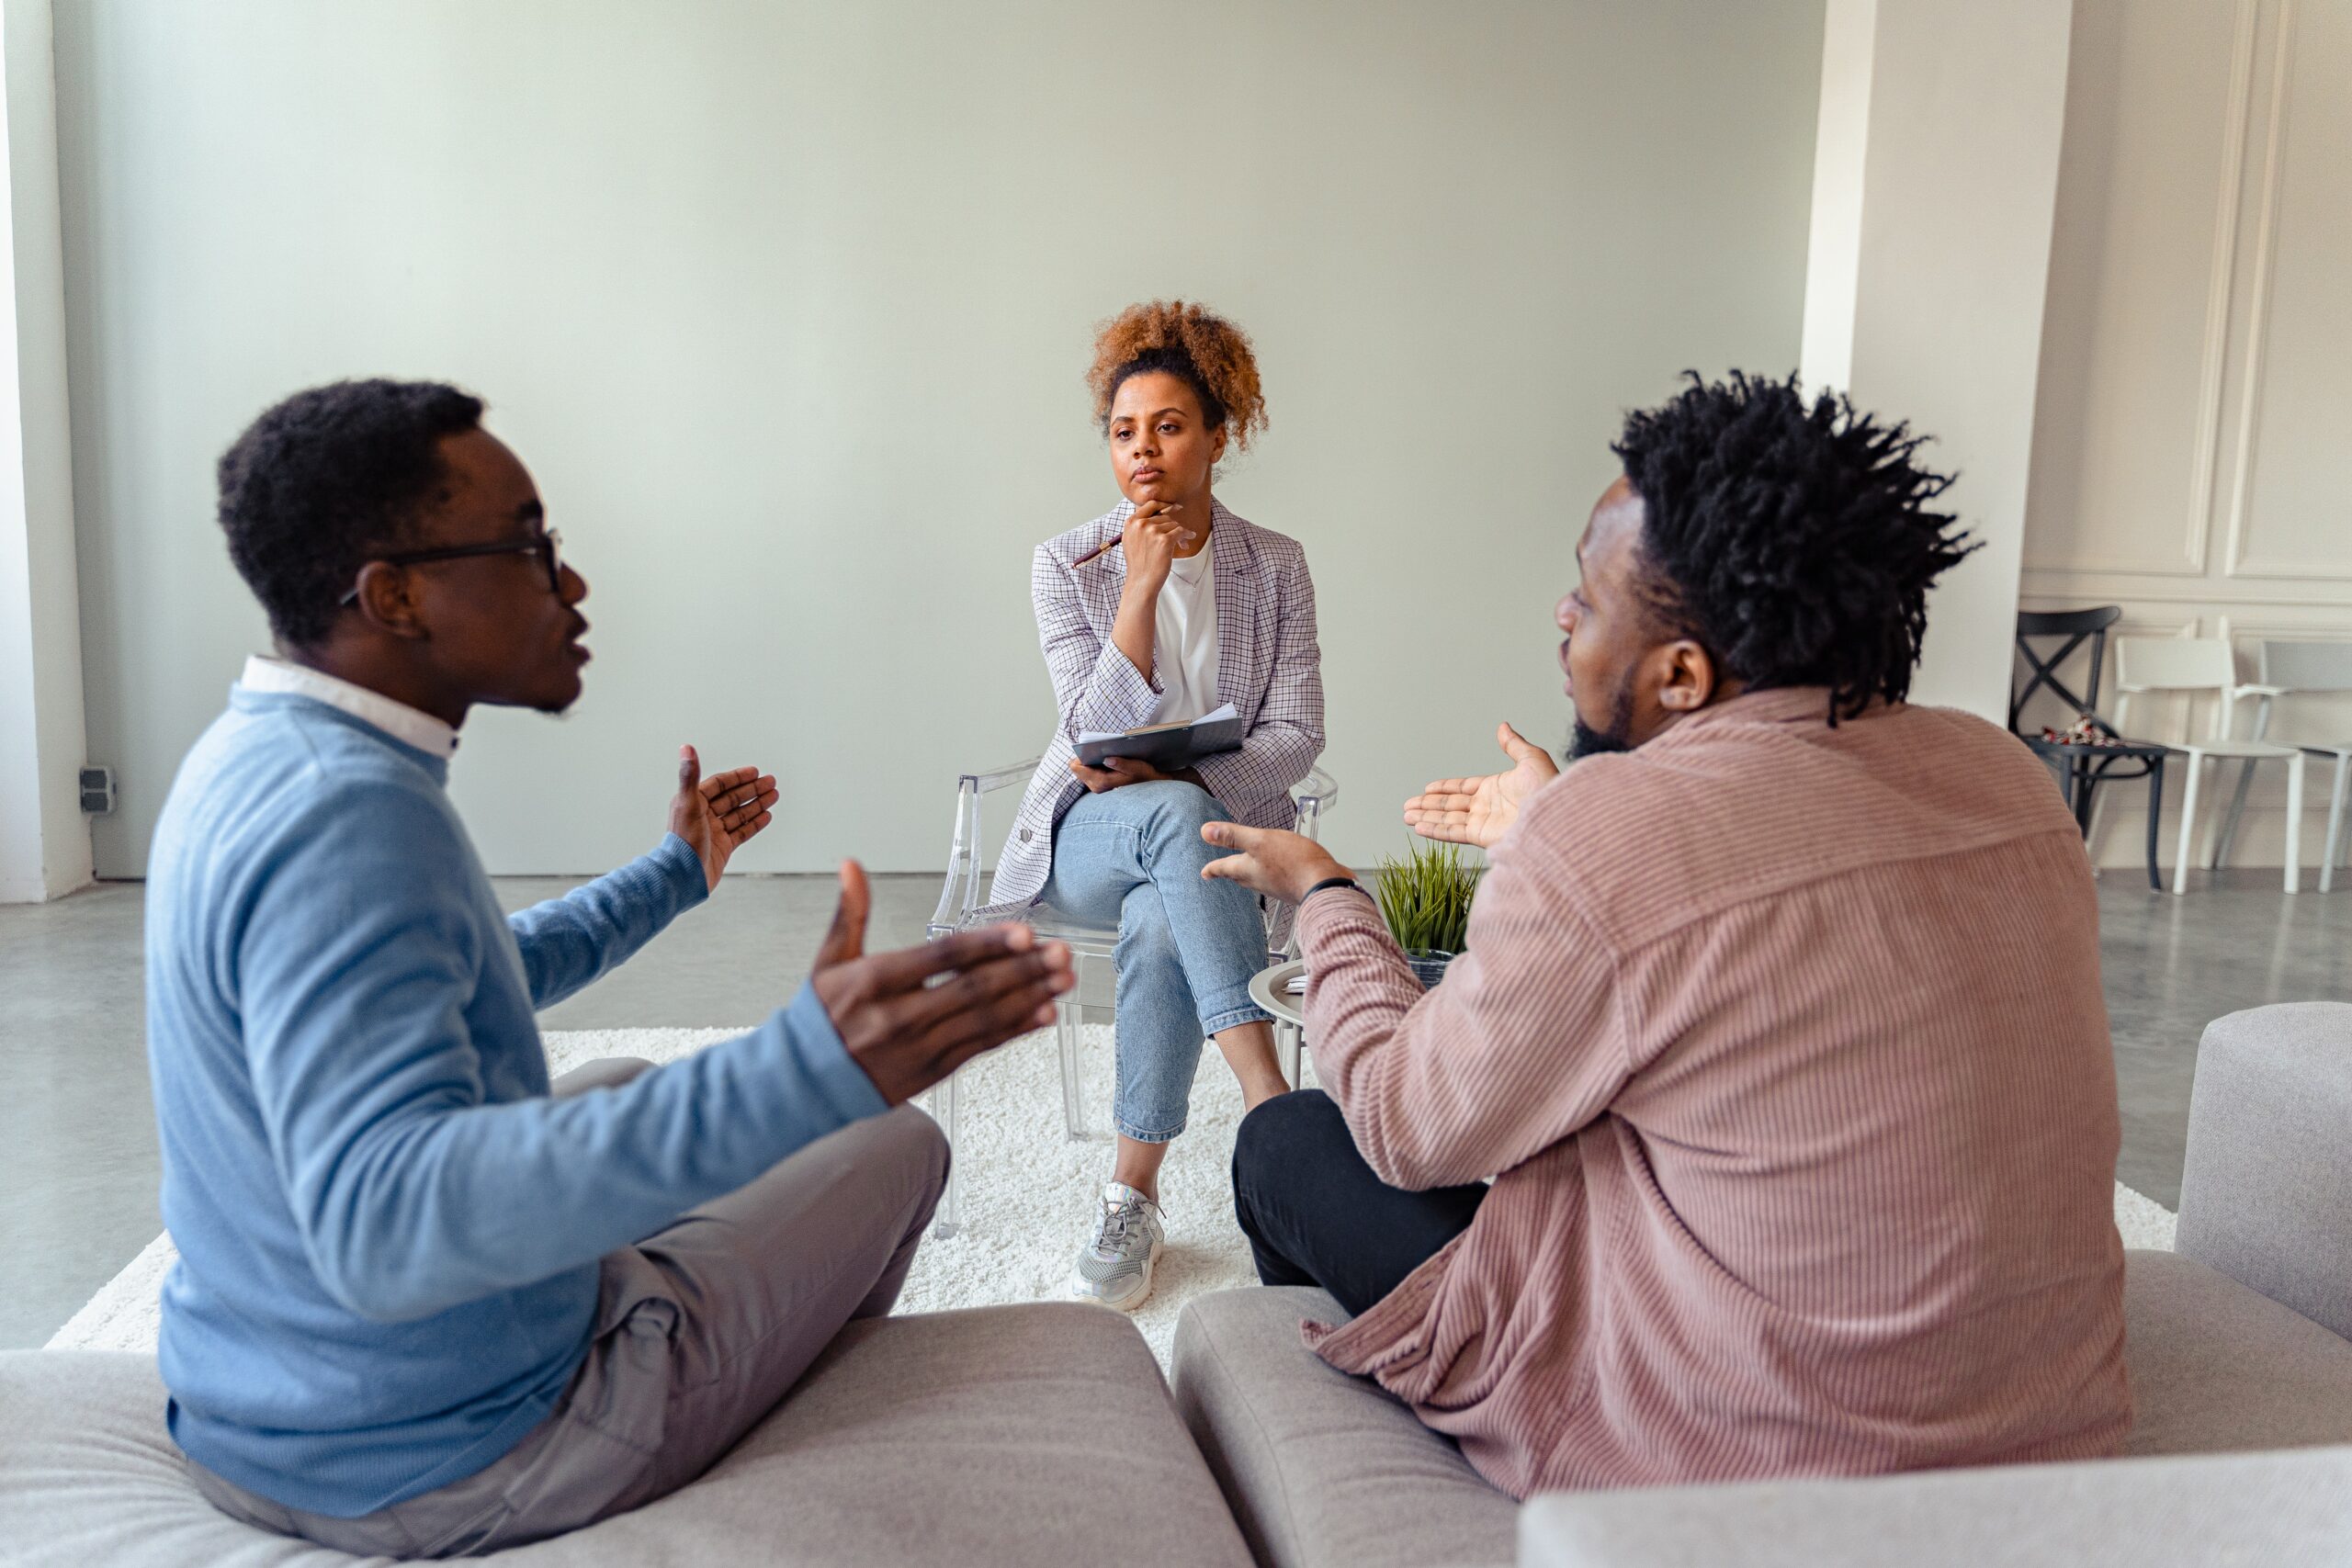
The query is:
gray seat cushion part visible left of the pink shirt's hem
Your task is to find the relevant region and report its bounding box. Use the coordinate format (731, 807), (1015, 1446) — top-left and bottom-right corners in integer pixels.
(1171, 1288), (1520, 1568)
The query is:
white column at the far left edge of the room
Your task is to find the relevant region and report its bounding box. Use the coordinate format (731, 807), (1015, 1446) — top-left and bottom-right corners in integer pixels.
(0, 0), (89, 903)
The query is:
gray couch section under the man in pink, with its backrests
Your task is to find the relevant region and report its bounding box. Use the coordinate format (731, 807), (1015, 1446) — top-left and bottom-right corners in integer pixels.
(1173, 1004), (2352, 1568)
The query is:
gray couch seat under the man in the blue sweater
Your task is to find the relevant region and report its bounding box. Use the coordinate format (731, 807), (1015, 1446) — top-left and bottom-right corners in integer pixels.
(0, 1303), (1249, 1568)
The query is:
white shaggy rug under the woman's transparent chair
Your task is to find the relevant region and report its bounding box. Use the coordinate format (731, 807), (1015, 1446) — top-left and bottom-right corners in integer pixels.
(50, 1025), (2176, 1366)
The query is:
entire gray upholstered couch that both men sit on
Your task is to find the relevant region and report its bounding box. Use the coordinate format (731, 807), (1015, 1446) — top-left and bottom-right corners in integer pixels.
(0, 1004), (2352, 1568)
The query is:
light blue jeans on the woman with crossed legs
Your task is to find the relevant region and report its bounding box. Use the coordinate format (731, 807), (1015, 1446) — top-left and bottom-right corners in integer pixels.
(1045, 778), (1265, 1143)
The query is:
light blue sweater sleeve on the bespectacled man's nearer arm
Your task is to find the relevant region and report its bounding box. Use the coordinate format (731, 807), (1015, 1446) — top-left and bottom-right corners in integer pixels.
(235, 783), (885, 1321)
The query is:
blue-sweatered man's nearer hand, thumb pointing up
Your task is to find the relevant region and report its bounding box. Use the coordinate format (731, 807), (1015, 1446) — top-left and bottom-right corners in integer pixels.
(809, 861), (1077, 1105)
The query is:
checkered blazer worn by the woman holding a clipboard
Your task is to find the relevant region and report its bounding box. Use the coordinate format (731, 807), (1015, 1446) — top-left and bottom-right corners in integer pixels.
(990, 501), (1322, 915)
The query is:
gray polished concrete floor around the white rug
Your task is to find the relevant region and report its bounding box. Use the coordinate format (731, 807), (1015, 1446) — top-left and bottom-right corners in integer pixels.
(0, 872), (2352, 1349)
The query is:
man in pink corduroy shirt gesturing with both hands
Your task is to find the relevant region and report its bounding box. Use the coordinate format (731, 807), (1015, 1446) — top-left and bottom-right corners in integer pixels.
(1204, 376), (2131, 1497)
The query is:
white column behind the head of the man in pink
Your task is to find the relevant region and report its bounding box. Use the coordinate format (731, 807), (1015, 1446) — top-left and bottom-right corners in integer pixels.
(1802, 0), (2072, 722)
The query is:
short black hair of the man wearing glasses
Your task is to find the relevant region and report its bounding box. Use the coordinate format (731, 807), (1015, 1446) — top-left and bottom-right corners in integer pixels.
(219, 381), (482, 649)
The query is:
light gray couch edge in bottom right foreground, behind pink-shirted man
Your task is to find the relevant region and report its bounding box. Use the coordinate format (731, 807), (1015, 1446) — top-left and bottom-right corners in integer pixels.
(1520, 1448), (2352, 1568)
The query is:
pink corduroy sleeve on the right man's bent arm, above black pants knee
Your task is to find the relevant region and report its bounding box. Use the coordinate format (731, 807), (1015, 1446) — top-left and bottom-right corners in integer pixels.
(1298, 799), (1633, 1192)
